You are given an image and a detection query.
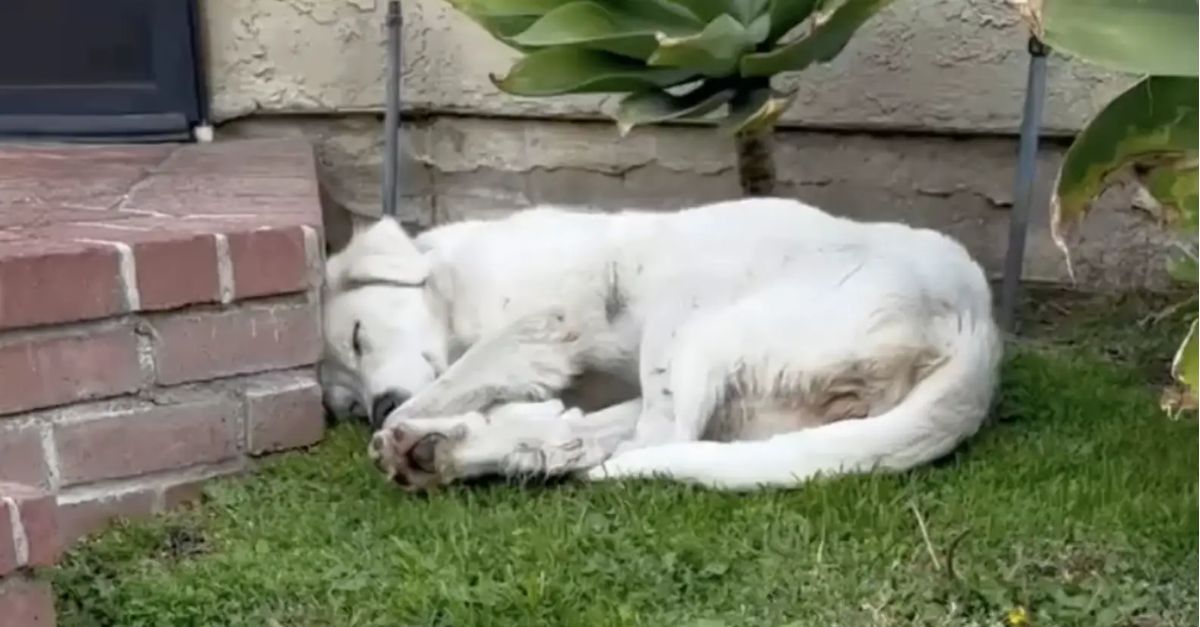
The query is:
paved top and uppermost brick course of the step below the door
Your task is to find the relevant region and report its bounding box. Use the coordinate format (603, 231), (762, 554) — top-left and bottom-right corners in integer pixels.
(0, 141), (320, 329)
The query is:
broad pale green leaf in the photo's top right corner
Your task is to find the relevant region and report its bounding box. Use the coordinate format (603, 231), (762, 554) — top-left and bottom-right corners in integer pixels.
(1020, 0), (1200, 76)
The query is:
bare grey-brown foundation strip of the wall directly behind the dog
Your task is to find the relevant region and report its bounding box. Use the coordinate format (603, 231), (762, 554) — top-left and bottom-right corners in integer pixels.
(236, 115), (1169, 289)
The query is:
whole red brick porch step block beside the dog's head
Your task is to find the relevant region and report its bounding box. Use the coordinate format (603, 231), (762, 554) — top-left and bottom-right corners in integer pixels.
(0, 142), (324, 552)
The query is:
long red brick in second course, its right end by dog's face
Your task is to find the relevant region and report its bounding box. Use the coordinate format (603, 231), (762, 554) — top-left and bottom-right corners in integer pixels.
(151, 303), (320, 384)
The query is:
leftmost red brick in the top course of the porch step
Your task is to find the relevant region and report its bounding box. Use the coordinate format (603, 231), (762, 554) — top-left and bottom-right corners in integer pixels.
(0, 239), (125, 329)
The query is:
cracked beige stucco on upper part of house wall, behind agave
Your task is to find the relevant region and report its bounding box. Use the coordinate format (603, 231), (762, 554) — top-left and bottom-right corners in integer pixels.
(203, 0), (1126, 132)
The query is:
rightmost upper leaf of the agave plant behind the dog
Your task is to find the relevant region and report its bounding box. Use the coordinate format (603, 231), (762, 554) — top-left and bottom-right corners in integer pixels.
(740, 0), (892, 77)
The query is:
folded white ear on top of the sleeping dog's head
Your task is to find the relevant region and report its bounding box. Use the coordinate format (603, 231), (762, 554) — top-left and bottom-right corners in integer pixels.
(325, 217), (430, 292)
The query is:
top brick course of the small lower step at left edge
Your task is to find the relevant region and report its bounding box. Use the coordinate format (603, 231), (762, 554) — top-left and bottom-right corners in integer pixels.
(0, 483), (60, 577)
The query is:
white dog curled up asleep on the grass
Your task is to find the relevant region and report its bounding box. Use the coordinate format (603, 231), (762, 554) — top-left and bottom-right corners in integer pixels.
(323, 198), (1002, 489)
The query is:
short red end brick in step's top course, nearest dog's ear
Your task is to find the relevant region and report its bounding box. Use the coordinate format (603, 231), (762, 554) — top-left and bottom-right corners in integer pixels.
(227, 226), (308, 299)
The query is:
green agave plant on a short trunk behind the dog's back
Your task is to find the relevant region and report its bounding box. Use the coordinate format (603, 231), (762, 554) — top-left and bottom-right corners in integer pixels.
(449, 0), (890, 195)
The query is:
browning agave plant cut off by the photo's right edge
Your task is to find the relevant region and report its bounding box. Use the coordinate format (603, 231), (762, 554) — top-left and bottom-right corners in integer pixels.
(1018, 0), (1200, 407)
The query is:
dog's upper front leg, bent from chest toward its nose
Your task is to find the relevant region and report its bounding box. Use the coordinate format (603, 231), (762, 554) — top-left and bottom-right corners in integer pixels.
(383, 312), (581, 428)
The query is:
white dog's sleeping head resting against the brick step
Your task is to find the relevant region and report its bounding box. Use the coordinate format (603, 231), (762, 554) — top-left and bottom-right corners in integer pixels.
(322, 219), (448, 424)
